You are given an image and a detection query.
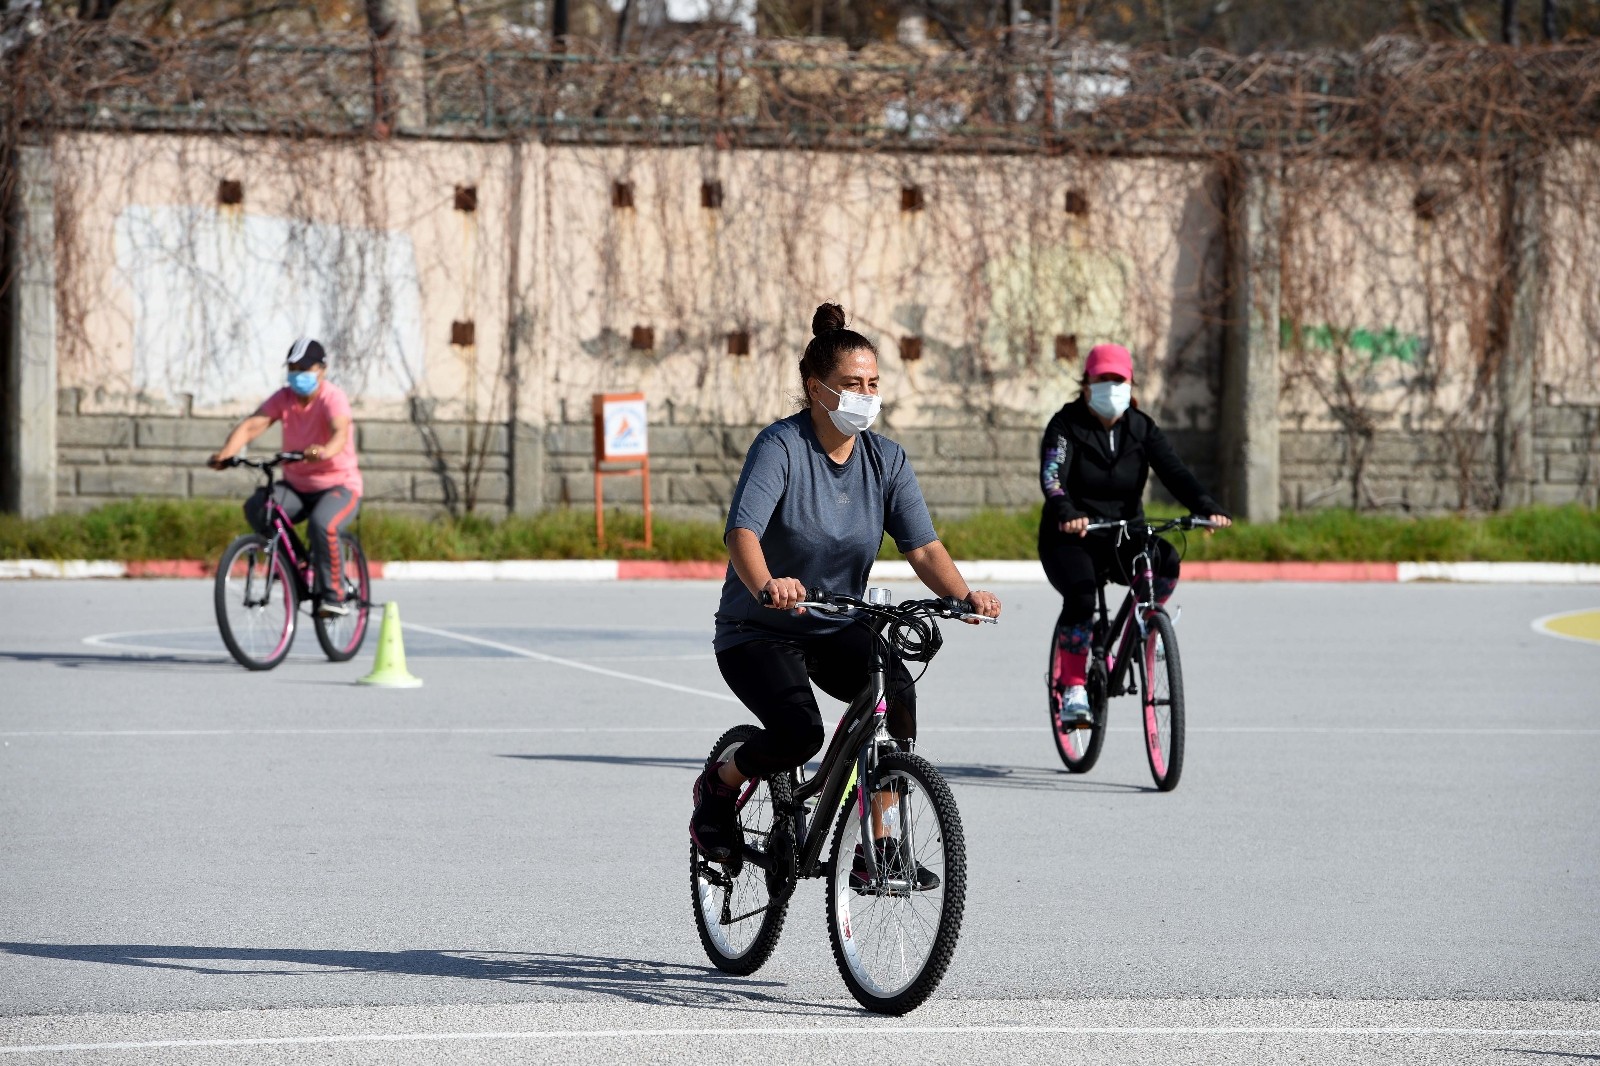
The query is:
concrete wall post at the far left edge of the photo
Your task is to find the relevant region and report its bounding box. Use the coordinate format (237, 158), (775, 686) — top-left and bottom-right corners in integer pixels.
(0, 146), (56, 519)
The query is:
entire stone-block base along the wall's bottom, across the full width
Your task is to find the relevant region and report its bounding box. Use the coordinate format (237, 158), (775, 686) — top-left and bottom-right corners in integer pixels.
(56, 389), (1600, 522)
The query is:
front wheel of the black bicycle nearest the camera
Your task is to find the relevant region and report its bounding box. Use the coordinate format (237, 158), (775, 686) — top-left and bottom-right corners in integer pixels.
(826, 752), (966, 1015)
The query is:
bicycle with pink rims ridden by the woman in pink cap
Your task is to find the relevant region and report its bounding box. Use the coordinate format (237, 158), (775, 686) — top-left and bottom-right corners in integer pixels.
(1045, 515), (1216, 792)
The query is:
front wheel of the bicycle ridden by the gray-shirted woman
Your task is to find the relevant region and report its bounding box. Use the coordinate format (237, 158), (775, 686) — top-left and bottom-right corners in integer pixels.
(827, 752), (966, 1015)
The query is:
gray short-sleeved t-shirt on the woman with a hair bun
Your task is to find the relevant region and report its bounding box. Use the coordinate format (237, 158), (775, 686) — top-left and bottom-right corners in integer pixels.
(712, 411), (938, 651)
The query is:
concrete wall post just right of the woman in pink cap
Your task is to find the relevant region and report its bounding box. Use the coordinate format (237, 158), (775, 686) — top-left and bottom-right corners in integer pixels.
(1219, 157), (1283, 522)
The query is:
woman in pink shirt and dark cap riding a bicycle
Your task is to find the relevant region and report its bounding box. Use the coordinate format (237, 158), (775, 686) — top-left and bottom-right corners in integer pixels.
(211, 336), (362, 615)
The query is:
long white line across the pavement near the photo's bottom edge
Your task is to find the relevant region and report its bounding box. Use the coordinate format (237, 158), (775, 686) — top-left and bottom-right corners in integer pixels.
(0, 1026), (1600, 1055)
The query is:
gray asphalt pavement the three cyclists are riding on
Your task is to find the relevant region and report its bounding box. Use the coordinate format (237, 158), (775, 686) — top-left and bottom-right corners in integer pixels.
(0, 581), (1600, 1063)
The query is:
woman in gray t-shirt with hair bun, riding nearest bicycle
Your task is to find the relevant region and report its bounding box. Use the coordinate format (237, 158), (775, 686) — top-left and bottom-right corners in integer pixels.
(690, 304), (1000, 861)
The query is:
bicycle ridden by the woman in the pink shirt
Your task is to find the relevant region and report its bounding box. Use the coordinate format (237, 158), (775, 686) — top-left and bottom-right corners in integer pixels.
(214, 451), (371, 671)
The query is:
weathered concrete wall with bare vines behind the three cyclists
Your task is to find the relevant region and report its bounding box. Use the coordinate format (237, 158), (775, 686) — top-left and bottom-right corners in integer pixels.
(13, 134), (1600, 519)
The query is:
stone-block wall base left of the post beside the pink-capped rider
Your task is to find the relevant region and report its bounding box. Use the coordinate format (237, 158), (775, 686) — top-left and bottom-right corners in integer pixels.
(56, 389), (1219, 522)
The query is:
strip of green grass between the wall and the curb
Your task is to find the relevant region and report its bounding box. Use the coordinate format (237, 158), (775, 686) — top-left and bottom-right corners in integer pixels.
(0, 499), (1600, 562)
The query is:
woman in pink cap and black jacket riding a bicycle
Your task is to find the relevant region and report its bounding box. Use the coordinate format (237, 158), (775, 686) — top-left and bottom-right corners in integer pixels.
(1038, 344), (1232, 728)
